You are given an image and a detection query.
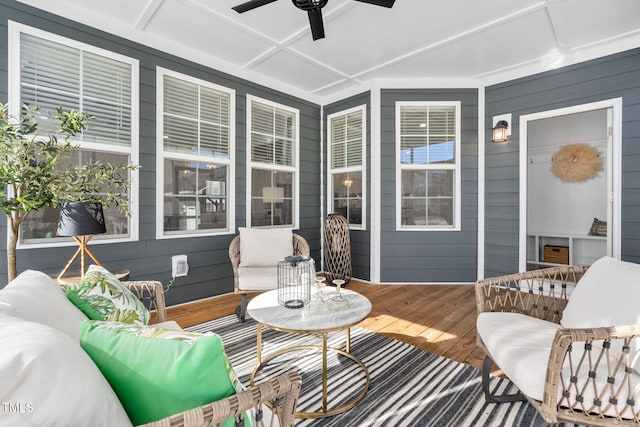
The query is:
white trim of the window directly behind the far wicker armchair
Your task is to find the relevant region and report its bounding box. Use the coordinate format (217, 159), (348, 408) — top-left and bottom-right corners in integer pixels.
(246, 94), (300, 229)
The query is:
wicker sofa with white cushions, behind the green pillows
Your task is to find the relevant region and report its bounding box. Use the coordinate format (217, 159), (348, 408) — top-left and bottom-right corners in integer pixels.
(0, 271), (300, 427)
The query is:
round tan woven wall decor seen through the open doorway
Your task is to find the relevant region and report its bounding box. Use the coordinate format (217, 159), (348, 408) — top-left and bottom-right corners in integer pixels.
(551, 142), (602, 182)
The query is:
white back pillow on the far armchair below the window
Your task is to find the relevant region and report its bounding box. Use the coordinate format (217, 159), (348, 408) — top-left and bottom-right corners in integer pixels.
(240, 227), (293, 267)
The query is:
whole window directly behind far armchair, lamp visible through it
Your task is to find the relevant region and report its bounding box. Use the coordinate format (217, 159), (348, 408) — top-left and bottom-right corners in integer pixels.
(247, 96), (299, 228)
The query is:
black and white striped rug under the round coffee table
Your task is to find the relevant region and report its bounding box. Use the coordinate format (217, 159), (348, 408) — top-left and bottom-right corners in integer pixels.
(187, 316), (568, 427)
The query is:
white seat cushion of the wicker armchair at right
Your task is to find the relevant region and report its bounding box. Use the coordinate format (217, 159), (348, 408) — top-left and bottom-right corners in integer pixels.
(476, 313), (560, 400)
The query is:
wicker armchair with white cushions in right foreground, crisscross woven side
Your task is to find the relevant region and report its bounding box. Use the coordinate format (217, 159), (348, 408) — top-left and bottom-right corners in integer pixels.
(476, 261), (640, 426)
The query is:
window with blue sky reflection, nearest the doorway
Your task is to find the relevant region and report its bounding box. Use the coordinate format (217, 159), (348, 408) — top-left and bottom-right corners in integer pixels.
(396, 102), (460, 230)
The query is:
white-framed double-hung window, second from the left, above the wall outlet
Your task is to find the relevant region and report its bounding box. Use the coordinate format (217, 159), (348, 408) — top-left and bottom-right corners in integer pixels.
(157, 68), (235, 238)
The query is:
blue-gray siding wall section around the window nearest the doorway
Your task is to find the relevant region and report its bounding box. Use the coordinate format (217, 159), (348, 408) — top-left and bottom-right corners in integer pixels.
(380, 89), (478, 282)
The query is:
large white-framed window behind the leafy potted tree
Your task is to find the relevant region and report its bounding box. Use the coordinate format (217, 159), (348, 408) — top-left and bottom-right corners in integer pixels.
(9, 22), (138, 247)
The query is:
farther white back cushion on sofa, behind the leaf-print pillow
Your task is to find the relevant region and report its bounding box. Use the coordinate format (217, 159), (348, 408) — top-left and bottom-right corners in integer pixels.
(0, 270), (87, 342)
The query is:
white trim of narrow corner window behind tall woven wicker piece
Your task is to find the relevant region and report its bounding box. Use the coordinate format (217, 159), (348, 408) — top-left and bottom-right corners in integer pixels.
(327, 104), (368, 230)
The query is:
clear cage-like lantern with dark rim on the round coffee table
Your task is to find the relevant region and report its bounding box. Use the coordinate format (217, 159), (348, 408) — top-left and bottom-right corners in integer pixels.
(278, 255), (316, 308)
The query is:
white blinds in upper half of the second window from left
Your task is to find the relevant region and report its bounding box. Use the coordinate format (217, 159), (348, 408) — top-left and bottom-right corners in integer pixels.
(163, 75), (231, 159)
